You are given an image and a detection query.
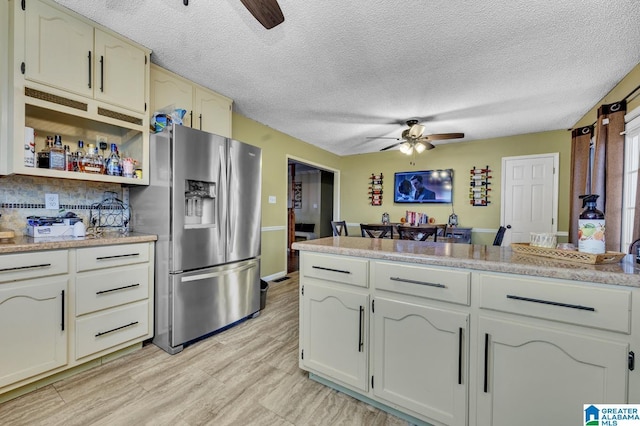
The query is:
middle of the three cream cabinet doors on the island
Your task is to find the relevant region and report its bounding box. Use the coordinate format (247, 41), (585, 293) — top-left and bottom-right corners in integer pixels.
(372, 297), (468, 425)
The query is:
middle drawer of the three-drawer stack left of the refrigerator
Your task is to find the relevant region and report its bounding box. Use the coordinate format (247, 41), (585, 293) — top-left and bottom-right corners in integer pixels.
(76, 263), (149, 315)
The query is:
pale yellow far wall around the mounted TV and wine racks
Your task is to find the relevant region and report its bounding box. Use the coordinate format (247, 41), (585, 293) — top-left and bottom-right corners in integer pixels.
(341, 130), (571, 244)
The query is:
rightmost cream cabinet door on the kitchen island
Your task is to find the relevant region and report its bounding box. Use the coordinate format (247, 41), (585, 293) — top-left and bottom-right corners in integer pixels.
(477, 317), (629, 426)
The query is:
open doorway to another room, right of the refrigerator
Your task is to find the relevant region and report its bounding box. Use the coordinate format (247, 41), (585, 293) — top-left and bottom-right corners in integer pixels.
(287, 158), (338, 273)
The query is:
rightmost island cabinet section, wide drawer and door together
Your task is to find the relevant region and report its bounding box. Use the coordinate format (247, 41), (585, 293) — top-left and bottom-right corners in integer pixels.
(474, 273), (631, 426)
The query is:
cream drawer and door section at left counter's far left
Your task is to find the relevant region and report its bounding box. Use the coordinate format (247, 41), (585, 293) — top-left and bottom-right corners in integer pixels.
(0, 250), (69, 389)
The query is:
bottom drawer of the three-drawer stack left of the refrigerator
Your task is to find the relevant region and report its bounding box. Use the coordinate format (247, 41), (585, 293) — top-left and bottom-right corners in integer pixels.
(76, 300), (149, 359)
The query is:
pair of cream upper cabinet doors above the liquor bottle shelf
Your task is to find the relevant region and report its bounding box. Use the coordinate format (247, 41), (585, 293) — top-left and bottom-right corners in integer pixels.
(25, 0), (147, 112)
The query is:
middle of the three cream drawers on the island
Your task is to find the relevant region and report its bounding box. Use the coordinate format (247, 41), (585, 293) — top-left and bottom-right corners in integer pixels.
(371, 262), (471, 306)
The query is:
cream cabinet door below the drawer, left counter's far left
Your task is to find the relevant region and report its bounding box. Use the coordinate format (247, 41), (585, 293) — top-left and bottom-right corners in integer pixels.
(0, 277), (67, 388)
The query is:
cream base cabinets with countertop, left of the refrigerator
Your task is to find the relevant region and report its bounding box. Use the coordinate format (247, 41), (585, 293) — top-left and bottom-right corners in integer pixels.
(0, 233), (157, 402)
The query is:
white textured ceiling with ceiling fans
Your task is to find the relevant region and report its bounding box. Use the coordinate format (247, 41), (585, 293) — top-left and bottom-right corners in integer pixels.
(57, 0), (640, 155)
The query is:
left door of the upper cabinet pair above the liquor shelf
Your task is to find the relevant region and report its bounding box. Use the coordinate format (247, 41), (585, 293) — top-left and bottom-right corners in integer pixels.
(25, 1), (93, 97)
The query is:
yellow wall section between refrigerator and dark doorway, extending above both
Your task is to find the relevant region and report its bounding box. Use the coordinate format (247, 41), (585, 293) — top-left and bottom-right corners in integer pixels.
(232, 113), (341, 277)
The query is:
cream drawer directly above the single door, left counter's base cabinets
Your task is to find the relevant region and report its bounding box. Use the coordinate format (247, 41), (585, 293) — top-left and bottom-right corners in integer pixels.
(0, 250), (69, 282)
